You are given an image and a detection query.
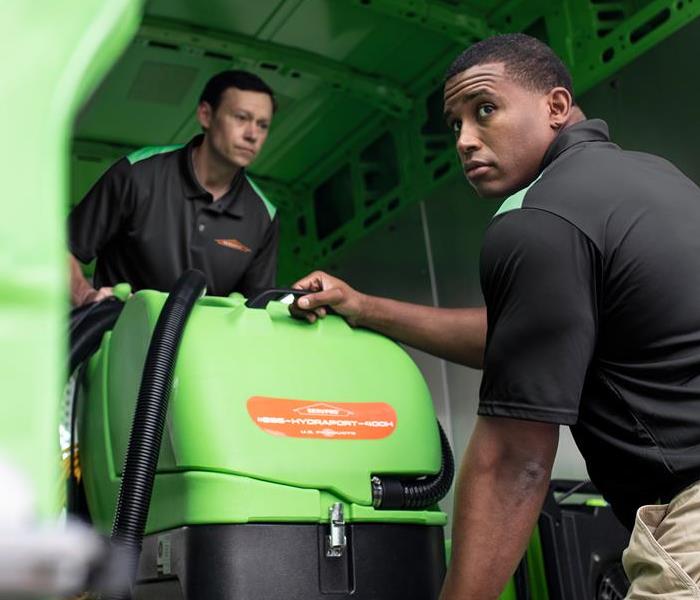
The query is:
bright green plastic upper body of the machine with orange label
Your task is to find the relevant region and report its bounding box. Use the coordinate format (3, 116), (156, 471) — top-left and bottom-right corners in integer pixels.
(79, 291), (446, 531)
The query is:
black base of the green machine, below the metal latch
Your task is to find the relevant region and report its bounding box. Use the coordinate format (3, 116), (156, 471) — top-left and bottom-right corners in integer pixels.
(133, 523), (445, 600)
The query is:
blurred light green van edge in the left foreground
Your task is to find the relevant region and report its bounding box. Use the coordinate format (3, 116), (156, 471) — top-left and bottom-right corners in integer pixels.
(0, 0), (140, 516)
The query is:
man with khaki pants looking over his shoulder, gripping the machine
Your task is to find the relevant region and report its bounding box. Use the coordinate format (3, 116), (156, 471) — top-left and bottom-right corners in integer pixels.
(297, 34), (700, 600)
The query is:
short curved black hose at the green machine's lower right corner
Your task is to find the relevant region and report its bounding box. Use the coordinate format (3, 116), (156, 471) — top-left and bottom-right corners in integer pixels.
(372, 421), (455, 510)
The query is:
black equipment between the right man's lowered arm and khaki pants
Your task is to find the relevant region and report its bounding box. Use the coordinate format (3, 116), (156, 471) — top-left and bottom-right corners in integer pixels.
(539, 480), (630, 600)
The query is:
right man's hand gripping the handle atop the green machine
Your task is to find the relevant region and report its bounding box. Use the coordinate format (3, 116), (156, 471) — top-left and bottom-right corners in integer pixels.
(290, 271), (367, 327)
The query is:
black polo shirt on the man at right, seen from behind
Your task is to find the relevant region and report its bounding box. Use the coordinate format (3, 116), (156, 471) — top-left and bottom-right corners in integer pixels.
(479, 120), (700, 527)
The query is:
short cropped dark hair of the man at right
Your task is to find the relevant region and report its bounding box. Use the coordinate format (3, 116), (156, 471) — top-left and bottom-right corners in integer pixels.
(445, 33), (574, 98)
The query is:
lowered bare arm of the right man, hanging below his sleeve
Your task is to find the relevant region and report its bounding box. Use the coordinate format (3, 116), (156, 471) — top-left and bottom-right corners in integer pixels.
(440, 422), (558, 600)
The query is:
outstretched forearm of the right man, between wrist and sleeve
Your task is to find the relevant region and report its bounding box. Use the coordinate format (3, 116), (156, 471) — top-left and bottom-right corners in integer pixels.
(357, 296), (486, 369)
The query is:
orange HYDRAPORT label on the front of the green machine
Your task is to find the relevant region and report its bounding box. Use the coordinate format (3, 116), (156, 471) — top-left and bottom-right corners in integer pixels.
(248, 396), (396, 440)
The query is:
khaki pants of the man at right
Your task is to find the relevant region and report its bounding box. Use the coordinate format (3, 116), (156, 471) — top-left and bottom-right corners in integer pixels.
(622, 482), (700, 600)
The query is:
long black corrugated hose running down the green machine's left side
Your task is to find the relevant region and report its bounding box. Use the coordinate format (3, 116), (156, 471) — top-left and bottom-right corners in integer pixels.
(104, 269), (206, 600)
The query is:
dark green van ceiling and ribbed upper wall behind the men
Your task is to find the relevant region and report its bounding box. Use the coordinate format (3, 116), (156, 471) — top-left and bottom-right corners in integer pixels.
(71, 0), (700, 283)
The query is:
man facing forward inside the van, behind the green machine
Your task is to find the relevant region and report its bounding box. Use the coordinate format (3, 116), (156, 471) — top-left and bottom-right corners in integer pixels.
(69, 71), (279, 306)
